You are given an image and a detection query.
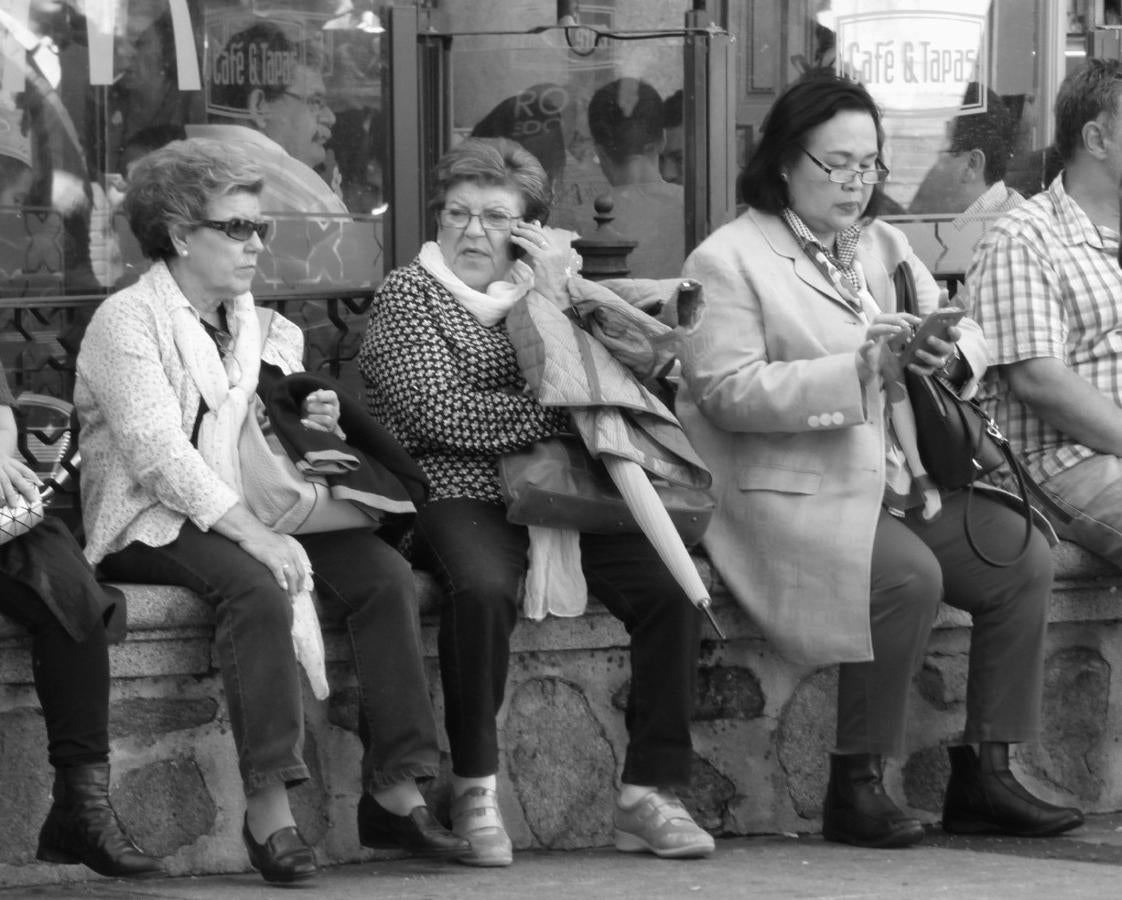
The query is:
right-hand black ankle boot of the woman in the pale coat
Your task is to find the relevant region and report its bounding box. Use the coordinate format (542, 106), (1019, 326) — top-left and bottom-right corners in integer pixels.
(942, 744), (1083, 837)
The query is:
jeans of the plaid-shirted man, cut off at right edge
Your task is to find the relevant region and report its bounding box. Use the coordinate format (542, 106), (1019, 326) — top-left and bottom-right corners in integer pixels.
(1041, 453), (1122, 568)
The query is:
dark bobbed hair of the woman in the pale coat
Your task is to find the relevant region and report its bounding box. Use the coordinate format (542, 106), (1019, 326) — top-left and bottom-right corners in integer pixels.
(737, 70), (884, 218)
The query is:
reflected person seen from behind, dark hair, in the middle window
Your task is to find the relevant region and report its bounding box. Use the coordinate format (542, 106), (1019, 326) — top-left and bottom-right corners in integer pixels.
(580, 79), (686, 278)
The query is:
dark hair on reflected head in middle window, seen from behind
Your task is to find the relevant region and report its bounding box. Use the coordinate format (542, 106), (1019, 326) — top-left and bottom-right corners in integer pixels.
(588, 79), (666, 163)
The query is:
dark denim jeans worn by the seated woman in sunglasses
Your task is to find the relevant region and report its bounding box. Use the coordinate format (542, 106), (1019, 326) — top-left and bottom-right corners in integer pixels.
(101, 522), (440, 793)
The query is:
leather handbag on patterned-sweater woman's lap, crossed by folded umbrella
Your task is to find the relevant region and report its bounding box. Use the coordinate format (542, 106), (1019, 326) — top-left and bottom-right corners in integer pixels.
(498, 434), (716, 547)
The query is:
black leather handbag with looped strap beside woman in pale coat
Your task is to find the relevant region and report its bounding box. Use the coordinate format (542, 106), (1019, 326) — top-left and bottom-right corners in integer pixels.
(893, 260), (1045, 568)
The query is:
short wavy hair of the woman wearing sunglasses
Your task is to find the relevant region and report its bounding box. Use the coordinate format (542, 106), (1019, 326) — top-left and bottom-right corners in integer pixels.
(125, 138), (265, 259)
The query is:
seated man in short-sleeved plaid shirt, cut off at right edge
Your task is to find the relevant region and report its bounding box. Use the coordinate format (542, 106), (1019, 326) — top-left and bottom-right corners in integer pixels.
(966, 59), (1122, 566)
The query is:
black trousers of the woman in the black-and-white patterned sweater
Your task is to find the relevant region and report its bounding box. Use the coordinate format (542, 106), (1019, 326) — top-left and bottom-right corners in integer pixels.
(415, 499), (701, 787)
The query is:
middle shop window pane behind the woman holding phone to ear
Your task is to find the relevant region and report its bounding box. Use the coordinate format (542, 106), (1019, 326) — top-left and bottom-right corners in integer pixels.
(451, 29), (686, 277)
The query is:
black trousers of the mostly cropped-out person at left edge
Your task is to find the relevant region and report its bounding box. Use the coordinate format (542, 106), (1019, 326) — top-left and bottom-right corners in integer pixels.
(0, 561), (109, 769)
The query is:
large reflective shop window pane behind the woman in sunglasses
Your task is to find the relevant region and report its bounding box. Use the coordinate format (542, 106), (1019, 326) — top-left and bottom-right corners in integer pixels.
(0, 0), (387, 296)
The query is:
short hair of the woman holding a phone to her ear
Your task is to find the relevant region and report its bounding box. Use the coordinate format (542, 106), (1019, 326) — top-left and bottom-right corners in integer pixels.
(429, 138), (550, 224)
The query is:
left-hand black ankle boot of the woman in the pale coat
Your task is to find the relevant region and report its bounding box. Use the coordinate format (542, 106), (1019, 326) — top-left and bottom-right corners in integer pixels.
(822, 753), (923, 847)
